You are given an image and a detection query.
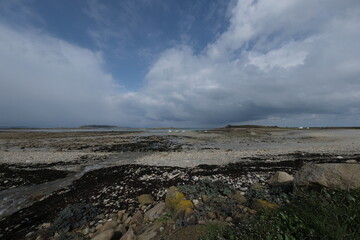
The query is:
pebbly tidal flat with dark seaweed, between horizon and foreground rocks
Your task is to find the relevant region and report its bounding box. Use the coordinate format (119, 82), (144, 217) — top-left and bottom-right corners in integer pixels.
(0, 127), (360, 239)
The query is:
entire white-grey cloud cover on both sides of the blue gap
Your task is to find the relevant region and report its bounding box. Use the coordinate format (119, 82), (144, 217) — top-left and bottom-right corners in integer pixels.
(0, 0), (360, 126)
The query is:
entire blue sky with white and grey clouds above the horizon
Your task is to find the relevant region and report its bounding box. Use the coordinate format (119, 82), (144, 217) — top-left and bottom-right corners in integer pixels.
(0, 0), (360, 127)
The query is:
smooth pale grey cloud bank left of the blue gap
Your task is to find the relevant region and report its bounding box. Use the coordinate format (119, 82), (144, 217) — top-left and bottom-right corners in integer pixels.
(0, 24), (121, 126)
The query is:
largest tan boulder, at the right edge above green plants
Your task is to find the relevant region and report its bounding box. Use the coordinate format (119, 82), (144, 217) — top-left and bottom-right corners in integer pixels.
(294, 163), (360, 190)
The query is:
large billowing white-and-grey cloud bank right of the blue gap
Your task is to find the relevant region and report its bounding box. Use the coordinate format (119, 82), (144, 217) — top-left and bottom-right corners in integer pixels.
(114, 0), (360, 125)
